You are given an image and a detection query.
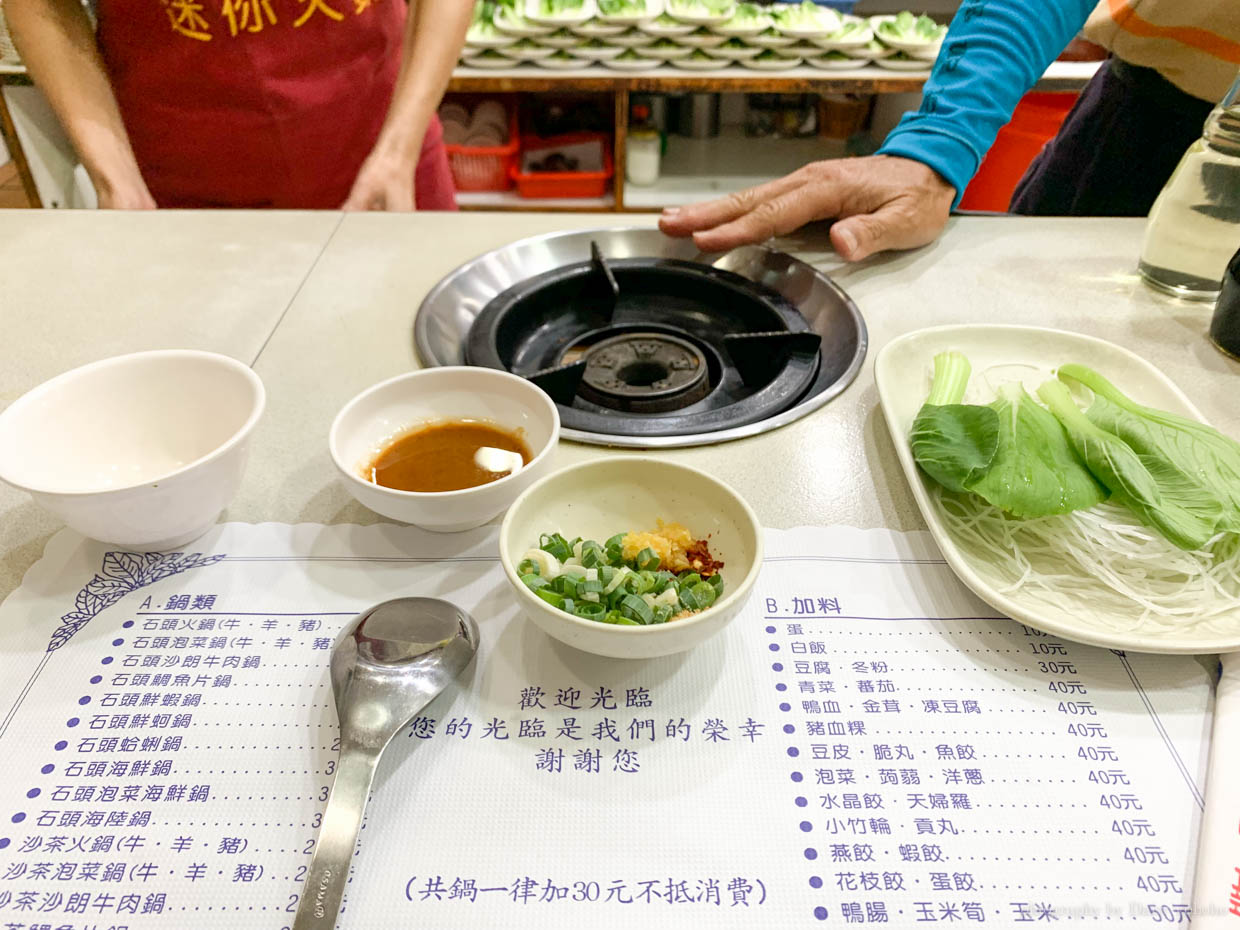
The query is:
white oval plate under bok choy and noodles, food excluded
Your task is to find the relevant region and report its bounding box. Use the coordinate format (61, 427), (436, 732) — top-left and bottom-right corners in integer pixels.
(874, 325), (1240, 653)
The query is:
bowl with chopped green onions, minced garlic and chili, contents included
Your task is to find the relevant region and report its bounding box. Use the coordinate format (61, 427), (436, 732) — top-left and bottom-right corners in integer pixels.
(500, 456), (763, 658)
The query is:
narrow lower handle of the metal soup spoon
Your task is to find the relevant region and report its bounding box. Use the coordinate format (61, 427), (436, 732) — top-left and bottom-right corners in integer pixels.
(293, 739), (379, 930)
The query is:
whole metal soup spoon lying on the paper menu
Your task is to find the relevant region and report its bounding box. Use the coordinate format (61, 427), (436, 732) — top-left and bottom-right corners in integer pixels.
(293, 598), (477, 930)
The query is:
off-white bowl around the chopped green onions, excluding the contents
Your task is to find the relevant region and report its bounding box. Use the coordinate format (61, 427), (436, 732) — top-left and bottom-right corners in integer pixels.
(500, 455), (763, 658)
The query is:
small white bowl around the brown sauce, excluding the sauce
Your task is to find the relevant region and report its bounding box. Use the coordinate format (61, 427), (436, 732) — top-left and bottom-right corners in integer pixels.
(327, 366), (559, 533)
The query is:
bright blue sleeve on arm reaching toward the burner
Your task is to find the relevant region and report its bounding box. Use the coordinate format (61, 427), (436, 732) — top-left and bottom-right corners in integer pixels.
(878, 0), (1096, 207)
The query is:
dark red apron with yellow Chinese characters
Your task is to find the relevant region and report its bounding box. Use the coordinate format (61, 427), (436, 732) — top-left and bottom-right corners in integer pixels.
(98, 0), (455, 210)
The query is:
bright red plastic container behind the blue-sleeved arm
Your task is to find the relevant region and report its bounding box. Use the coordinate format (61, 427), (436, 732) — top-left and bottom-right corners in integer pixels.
(960, 93), (1076, 212)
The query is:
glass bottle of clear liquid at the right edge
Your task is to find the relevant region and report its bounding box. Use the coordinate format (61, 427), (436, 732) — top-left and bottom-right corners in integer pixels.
(1137, 74), (1240, 300)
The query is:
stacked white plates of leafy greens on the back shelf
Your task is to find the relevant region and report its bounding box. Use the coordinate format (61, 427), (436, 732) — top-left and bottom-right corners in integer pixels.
(461, 0), (942, 71)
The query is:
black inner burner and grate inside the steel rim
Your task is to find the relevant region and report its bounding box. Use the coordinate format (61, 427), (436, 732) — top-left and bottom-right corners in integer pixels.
(465, 247), (820, 436)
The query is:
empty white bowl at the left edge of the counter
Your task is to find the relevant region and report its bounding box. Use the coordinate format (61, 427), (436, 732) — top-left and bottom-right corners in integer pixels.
(0, 350), (267, 549)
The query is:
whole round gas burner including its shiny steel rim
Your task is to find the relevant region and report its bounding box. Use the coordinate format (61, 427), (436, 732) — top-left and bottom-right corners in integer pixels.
(415, 229), (866, 446)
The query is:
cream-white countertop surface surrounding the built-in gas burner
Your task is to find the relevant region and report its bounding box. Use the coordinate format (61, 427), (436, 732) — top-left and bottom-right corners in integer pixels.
(0, 211), (1240, 596)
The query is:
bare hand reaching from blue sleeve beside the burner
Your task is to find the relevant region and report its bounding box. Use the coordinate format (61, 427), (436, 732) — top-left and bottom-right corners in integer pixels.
(658, 155), (956, 262)
